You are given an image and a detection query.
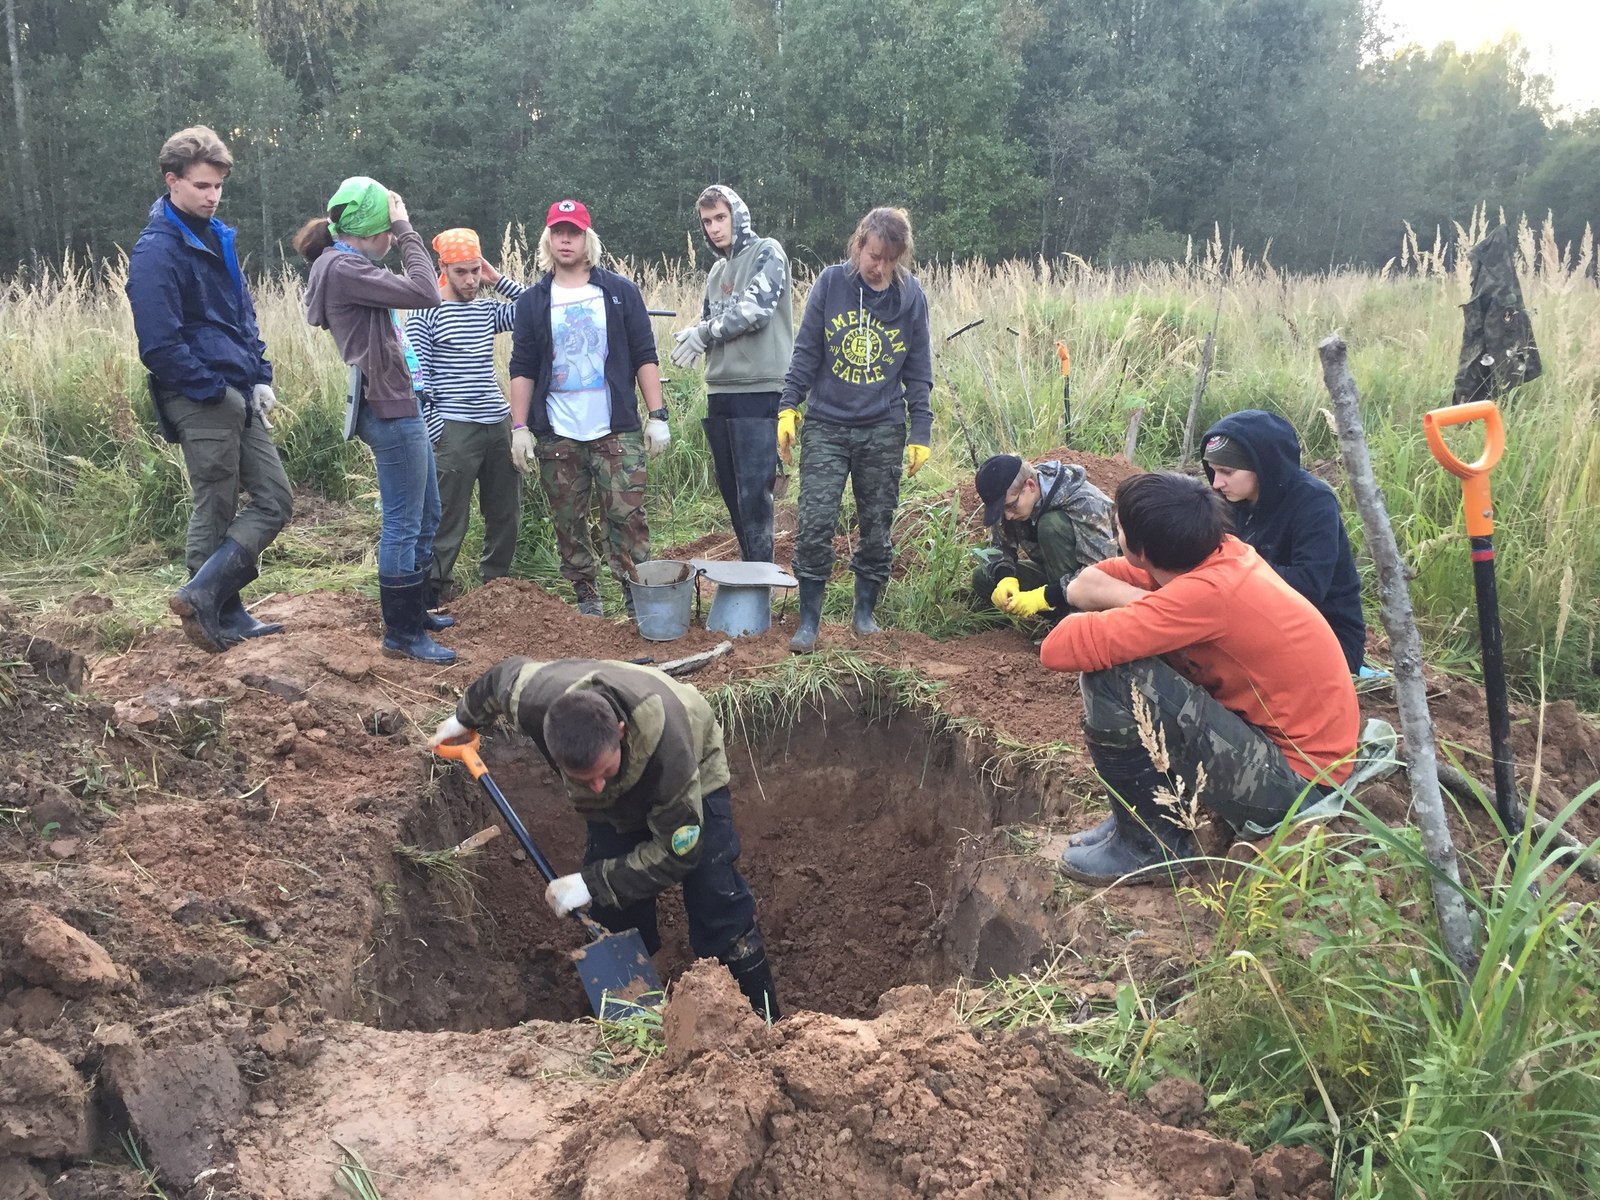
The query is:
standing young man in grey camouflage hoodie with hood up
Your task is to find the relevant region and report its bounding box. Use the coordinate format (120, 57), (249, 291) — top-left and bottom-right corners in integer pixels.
(672, 184), (795, 563)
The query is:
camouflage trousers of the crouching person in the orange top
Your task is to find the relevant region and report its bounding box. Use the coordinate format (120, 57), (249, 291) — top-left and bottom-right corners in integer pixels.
(1069, 659), (1333, 829)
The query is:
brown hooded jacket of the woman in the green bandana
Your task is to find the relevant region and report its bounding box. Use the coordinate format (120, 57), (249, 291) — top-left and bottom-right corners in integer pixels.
(306, 221), (438, 419)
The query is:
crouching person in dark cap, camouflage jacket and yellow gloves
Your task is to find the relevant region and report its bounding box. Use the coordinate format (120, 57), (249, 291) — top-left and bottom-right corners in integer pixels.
(973, 454), (1117, 621)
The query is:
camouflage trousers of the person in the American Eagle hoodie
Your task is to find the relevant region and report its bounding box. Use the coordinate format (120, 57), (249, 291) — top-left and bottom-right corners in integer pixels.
(794, 418), (906, 584)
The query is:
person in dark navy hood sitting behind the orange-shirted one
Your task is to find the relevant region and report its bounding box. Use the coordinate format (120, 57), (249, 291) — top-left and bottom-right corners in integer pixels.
(1202, 408), (1366, 675)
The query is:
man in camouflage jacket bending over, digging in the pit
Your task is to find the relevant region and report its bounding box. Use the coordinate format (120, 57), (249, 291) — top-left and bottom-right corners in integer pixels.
(429, 658), (778, 1021)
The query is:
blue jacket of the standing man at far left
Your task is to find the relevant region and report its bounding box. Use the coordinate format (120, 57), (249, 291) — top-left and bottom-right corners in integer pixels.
(128, 195), (272, 405)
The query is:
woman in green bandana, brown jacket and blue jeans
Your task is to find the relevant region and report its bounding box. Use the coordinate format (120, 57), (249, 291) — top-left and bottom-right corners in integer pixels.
(294, 176), (456, 664)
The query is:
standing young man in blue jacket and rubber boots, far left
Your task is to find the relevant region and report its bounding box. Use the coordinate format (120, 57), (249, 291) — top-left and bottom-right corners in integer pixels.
(128, 125), (294, 654)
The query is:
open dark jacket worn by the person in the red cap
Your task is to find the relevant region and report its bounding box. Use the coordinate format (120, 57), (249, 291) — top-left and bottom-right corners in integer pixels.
(510, 267), (661, 437)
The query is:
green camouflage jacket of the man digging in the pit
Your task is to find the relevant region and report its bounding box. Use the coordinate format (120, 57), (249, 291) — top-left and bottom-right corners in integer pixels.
(456, 658), (728, 907)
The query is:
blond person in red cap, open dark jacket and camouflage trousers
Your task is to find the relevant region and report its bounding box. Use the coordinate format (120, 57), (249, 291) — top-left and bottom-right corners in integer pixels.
(510, 200), (672, 616)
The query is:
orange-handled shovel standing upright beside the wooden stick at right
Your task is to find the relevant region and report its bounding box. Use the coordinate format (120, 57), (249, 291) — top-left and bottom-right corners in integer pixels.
(1422, 400), (1523, 840)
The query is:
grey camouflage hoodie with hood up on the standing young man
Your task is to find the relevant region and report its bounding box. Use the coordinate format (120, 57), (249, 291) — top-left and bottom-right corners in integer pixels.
(699, 184), (795, 392)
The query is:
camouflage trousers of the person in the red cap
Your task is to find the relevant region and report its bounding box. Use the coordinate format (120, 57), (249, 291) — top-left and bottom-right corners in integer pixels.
(534, 430), (650, 598)
